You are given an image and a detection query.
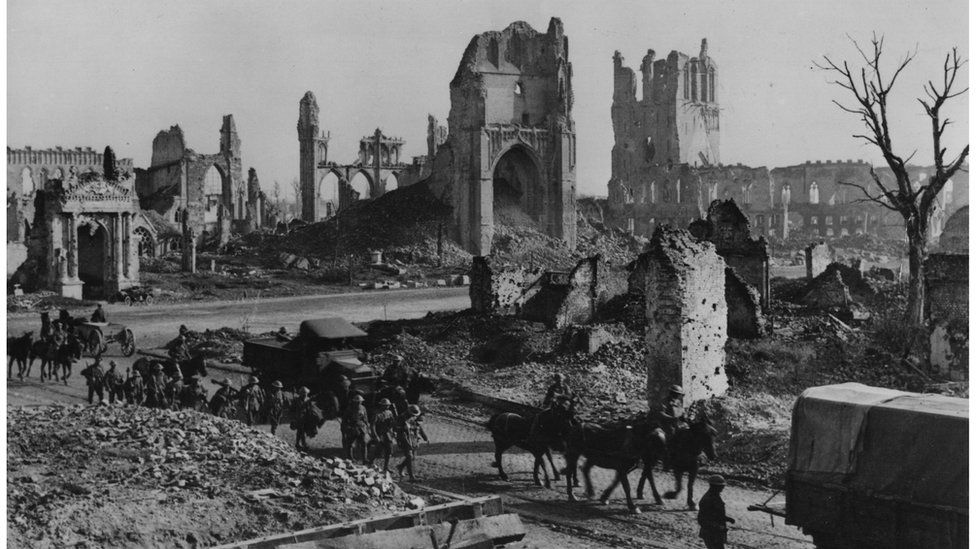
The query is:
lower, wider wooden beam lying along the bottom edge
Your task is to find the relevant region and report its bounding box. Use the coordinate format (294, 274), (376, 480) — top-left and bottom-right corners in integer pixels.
(276, 514), (525, 549)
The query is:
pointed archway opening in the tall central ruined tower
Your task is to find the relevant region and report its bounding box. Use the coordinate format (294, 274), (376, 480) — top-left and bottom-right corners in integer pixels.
(492, 146), (546, 228)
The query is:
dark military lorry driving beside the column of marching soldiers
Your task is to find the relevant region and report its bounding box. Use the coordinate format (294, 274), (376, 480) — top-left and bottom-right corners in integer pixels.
(242, 317), (379, 398)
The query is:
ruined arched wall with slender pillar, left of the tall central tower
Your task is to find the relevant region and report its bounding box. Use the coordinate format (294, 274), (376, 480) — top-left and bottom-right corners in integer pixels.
(298, 91), (438, 223)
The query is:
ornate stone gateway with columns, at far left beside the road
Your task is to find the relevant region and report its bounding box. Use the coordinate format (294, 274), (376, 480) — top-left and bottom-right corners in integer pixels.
(25, 170), (148, 299)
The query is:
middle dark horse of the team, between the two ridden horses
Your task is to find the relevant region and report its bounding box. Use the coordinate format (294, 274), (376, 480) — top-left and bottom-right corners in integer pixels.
(566, 423), (646, 514)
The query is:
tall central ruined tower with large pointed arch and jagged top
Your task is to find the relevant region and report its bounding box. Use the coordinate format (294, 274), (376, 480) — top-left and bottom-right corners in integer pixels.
(429, 18), (576, 255)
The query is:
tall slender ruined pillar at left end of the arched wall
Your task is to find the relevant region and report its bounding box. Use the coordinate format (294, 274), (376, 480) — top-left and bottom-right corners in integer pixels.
(298, 91), (329, 223)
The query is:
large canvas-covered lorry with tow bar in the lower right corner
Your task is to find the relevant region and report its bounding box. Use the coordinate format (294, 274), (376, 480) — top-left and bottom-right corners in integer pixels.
(750, 383), (969, 549)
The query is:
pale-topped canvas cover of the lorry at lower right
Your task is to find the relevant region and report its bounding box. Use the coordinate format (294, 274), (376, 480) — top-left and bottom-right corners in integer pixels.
(787, 383), (969, 512)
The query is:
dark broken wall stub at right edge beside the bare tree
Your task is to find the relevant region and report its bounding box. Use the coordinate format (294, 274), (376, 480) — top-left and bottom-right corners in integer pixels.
(925, 253), (969, 381)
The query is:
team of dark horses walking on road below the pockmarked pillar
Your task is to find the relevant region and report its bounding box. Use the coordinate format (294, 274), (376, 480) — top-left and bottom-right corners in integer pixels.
(487, 398), (716, 514)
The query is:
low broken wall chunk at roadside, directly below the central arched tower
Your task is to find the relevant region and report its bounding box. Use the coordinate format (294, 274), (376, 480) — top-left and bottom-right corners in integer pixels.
(468, 256), (542, 314)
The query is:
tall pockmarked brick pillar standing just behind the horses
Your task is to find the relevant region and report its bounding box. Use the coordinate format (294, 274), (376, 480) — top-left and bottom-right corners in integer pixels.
(645, 227), (728, 406)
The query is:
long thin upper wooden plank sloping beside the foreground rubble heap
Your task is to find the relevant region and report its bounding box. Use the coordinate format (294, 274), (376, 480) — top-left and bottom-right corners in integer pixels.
(214, 496), (503, 549)
